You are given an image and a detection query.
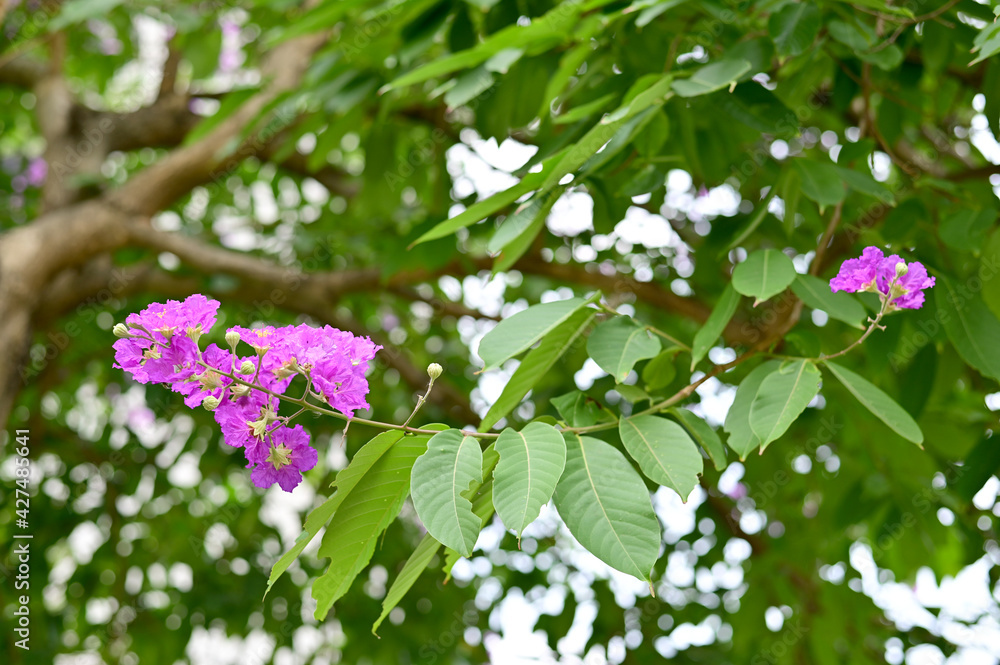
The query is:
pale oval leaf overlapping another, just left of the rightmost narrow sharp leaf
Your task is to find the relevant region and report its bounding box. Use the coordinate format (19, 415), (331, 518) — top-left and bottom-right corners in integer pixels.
(750, 360), (820, 452)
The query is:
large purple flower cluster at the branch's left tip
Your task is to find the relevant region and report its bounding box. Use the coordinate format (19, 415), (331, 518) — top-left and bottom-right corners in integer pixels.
(114, 294), (382, 492)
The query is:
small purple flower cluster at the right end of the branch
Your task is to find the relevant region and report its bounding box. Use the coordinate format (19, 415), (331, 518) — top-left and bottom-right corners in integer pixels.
(830, 247), (935, 311)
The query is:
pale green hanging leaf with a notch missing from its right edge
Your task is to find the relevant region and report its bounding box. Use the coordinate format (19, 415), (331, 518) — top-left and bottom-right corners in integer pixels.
(411, 429), (483, 556)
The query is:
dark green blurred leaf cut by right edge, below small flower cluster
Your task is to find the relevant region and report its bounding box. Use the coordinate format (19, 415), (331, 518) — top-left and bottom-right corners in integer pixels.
(934, 277), (1000, 379)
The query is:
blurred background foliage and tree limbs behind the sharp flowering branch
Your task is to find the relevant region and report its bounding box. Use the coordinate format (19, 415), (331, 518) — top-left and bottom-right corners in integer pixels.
(0, 0), (1000, 664)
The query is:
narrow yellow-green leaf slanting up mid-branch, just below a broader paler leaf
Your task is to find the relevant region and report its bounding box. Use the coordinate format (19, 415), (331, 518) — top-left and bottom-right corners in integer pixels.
(479, 309), (596, 432)
